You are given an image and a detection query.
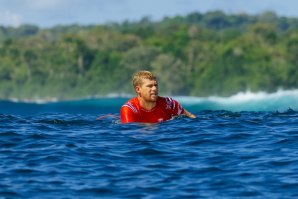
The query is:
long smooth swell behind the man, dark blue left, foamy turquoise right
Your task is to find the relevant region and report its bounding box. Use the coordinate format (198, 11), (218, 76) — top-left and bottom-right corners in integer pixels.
(0, 90), (298, 115)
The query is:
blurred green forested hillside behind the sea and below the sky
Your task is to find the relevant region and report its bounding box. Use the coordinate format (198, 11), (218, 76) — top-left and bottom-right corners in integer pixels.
(0, 11), (298, 99)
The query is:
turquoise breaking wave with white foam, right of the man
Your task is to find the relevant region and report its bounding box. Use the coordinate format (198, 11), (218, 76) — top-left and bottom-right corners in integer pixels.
(173, 89), (298, 111)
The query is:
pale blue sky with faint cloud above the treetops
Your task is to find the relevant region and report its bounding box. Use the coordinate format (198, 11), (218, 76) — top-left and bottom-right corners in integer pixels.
(0, 0), (298, 28)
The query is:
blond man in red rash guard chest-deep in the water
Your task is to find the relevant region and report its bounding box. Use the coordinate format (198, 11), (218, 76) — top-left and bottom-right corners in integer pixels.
(120, 71), (196, 123)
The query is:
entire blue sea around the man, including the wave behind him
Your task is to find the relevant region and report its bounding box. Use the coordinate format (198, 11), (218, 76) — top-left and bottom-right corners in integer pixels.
(0, 90), (298, 199)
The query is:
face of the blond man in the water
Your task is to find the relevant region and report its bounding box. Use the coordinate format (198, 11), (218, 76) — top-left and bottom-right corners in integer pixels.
(136, 79), (158, 102)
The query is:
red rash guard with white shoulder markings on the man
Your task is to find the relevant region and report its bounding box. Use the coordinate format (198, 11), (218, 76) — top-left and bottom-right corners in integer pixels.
(120, 97), (184, 123)
